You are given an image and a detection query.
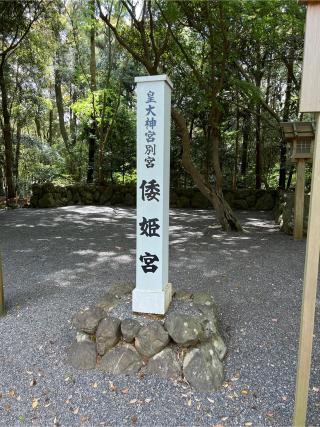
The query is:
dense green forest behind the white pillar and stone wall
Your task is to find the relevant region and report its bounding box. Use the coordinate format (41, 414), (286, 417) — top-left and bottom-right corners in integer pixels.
(0, 0), (307, 229)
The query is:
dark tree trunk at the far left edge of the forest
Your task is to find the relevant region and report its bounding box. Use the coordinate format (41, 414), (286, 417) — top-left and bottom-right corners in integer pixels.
(0, 60), (16, 203)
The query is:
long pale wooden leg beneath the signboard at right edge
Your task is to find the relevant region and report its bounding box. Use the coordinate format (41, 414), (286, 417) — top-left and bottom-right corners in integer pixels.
(293, 113), (320, 427)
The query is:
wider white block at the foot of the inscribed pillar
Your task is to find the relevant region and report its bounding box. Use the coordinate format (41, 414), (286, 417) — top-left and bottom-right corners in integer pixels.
(132, 283), (172, 314)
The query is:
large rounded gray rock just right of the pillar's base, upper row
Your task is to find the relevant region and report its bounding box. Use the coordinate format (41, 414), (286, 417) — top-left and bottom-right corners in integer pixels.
(164, 313), (206, 347)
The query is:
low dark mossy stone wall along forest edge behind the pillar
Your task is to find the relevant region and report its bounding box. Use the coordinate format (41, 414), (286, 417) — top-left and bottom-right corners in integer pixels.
(30, 183), (278, 210)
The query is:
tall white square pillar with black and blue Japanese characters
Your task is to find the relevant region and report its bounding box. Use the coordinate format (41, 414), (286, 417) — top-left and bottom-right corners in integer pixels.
(132, 75), (172, 314)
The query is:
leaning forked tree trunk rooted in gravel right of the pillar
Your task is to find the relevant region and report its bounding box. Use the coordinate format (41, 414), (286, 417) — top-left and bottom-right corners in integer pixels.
(172, 108), (242, 231)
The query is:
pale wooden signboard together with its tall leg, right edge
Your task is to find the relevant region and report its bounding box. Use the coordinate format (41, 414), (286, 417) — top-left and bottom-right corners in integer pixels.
(293, 0), (320, 427)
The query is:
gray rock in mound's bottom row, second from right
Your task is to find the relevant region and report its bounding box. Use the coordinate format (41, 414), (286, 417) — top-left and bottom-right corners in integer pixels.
(146, 348), (181, 378)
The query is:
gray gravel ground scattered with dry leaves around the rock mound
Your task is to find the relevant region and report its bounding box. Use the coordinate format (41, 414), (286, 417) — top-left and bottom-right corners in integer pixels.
(0, 206), (320, 426)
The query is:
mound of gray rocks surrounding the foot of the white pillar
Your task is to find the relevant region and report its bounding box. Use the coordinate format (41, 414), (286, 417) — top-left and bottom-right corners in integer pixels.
(67, 284), (227, 391)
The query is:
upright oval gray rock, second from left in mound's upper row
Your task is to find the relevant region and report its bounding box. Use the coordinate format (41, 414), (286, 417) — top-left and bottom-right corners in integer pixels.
(96, 317), (121, 355)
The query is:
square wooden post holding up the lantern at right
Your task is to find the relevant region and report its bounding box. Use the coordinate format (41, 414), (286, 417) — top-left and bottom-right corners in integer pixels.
(293, 159), (305, 240)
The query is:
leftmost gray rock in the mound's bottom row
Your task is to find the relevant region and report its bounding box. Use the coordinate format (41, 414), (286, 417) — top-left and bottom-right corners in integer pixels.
(67, 341), (97, 369)
